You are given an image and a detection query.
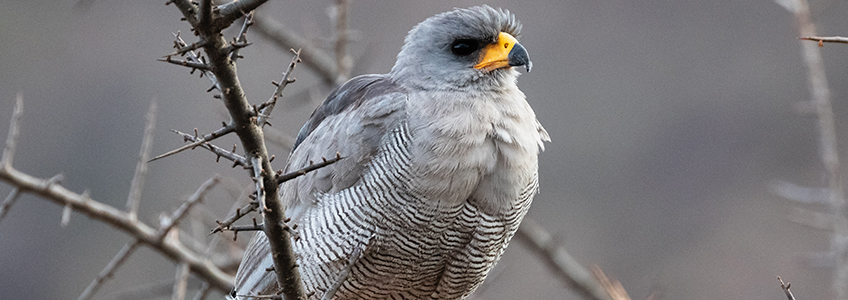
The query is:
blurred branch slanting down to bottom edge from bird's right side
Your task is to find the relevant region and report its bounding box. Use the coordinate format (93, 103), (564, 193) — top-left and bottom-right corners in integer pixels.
(516, 217), (610, 300)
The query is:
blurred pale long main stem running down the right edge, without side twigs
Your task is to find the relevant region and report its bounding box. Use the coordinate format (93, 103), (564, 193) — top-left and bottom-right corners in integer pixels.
(778, 0), (848, 299)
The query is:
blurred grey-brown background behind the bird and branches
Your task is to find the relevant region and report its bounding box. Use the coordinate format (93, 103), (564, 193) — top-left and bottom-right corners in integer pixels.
(0, 0), (848, 299)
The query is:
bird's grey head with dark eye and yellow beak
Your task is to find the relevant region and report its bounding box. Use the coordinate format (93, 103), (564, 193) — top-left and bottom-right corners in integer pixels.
(390, 5), (532, 90)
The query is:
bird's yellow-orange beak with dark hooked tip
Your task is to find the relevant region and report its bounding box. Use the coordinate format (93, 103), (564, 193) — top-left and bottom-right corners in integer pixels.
(474, 32), (532, 72)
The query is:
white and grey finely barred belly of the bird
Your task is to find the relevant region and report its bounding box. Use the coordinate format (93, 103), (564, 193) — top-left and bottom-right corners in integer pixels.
(237, 122), (537, 299)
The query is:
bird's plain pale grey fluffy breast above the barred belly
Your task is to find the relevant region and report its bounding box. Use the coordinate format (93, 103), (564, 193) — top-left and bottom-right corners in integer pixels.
(410, 89), (540, 213)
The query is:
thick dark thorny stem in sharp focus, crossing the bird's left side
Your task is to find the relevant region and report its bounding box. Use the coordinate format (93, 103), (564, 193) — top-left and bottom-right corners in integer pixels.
(173, 0), (305, 299)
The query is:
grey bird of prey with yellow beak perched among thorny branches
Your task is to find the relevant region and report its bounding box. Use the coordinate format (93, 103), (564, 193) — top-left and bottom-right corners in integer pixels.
(230, 5), (550, 300)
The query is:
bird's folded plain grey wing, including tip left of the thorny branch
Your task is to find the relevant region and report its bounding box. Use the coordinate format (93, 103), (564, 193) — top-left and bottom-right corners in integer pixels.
(229, 75), (407, 295)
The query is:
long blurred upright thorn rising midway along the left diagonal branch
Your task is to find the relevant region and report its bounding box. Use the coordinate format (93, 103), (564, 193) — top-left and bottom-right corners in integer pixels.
(127, 100), (156, 218)
